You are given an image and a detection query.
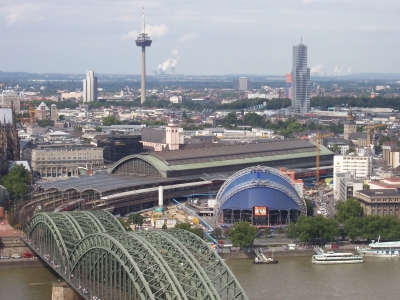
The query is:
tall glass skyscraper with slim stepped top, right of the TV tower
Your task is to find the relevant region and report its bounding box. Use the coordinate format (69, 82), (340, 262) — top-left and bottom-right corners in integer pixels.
(292, 42), (310, 114)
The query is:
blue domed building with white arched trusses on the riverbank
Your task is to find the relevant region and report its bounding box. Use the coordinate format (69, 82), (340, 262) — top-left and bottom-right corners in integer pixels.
(214, 166), (307, 227)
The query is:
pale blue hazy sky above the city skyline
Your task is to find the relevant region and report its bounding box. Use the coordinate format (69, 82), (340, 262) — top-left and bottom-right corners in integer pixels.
(0, 0), (400, 76)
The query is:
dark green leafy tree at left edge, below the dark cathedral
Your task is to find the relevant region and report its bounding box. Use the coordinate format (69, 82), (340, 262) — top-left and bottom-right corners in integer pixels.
(0, 165), (31, 200)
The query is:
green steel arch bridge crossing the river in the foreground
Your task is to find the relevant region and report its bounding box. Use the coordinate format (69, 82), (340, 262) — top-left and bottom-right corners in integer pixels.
(26, 210), (248, 300)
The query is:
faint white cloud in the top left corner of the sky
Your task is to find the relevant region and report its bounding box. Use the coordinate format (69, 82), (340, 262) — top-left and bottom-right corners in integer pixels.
(1, 4), (44, 26)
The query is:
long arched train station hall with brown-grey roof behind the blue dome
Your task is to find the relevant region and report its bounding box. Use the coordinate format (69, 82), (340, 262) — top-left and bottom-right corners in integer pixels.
(108, 140), (334, 178)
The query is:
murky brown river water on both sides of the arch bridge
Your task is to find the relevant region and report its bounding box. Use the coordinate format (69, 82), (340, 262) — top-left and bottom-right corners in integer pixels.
(0, 257), (400, 300)
